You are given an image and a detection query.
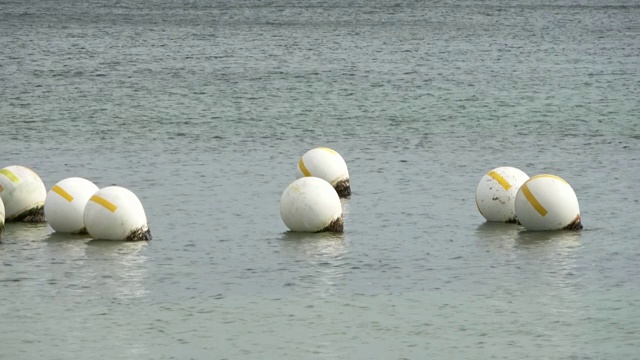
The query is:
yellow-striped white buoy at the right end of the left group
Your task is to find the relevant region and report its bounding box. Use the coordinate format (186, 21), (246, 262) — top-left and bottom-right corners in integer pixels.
(83, 186), (151, 241)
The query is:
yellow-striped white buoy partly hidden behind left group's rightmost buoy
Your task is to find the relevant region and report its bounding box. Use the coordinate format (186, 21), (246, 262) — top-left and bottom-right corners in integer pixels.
(44, 177), (98, 234)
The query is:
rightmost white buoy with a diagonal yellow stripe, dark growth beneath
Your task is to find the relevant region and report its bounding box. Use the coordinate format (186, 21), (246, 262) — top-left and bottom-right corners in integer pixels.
(515, 174), (582, 230)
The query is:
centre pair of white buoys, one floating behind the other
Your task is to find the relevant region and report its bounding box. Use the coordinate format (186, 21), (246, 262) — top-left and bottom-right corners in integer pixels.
(280, 147), (351, 232)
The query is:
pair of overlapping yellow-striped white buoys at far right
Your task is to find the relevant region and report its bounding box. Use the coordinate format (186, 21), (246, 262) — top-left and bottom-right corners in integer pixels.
(476, 166), (582, 231)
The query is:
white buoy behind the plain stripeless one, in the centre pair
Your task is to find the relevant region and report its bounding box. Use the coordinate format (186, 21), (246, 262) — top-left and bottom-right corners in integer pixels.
(296, 147), (351, 198)
